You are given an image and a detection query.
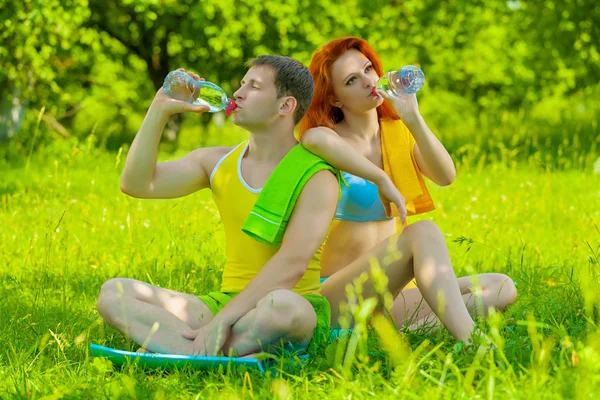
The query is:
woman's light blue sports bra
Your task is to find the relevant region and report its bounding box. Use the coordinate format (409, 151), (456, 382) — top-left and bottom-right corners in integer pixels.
(335, 172), (394, 222)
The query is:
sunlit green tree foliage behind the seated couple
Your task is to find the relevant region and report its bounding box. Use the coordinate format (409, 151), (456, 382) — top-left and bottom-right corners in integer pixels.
(0, 0), (600, 168)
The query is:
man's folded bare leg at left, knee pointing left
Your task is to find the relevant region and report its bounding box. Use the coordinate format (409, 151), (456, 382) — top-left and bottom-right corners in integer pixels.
(97, 278), (213, 354)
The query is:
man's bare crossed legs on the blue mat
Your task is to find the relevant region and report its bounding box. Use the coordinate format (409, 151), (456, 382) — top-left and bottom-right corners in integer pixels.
(97, 278), (329, 357)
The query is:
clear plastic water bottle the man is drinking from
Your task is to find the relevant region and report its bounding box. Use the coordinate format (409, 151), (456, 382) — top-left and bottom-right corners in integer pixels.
(163, 70), (236, 115)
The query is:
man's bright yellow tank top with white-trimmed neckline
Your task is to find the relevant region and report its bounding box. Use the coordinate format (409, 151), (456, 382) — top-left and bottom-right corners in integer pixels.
(210, 141), (323, 294)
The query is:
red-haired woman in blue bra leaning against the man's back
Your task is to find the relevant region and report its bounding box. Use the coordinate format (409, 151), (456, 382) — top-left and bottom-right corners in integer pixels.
(300, 37), (516, 339)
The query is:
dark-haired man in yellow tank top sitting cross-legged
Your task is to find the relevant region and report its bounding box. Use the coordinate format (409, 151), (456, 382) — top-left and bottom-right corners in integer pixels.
(98, 56), (339, 356)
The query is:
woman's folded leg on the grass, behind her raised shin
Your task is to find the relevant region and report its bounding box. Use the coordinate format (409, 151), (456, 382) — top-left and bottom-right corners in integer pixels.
(391, 273), (517, 330)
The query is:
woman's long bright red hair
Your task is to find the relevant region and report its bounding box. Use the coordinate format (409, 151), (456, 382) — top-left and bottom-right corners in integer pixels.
(299, 36), (400, 135)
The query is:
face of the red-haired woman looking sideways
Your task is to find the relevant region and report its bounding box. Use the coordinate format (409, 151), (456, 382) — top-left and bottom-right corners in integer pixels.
(331, 49), (383, 114)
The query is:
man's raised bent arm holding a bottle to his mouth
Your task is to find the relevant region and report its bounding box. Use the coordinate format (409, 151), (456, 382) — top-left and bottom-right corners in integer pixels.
(121, 73), (229, 199)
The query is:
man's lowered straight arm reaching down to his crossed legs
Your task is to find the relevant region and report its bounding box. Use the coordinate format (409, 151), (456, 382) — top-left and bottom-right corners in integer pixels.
(213, 171), (339, 327)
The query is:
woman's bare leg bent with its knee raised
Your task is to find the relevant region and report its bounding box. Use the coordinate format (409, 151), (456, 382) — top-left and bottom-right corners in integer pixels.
(322, 221), (475, 340)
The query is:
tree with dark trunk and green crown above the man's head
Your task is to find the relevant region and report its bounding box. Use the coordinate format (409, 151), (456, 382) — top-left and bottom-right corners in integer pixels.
(86, 0), (364, 138)
